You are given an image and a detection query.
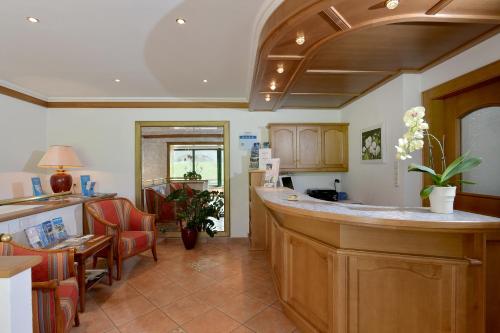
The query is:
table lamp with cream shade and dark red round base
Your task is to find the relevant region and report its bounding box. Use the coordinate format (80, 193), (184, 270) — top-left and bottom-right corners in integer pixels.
(38, 146), (83, 193)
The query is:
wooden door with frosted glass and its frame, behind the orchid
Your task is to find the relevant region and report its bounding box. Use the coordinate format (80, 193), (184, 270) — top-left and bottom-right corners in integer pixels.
(423, 61), (500, 217)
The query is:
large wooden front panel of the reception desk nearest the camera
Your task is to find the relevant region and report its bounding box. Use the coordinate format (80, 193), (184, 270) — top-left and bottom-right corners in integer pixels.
(334, 251), (467, 333)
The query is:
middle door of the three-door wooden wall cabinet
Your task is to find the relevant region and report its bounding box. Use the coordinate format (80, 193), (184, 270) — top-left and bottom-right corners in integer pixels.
(297, 126), (321, 169)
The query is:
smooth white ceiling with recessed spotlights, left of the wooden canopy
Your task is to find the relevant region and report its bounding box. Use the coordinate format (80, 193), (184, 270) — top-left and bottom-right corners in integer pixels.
(0, 0), (283, 101)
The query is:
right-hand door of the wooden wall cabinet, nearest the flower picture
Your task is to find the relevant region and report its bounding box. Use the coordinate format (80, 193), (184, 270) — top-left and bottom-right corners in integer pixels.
(321, 125), (349, 171)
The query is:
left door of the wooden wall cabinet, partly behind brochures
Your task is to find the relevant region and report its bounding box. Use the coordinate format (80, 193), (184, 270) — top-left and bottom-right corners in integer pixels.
(269, 126), (297, 169)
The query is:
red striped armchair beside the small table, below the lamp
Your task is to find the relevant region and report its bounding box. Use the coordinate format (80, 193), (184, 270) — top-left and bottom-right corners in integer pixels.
(85, 198), (157, 280)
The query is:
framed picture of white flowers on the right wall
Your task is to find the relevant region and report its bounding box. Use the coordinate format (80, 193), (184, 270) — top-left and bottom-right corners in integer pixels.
(361, 123), (385, 163)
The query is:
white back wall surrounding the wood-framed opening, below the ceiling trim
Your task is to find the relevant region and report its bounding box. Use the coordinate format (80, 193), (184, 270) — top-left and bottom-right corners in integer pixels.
(47, 109), (340, 237)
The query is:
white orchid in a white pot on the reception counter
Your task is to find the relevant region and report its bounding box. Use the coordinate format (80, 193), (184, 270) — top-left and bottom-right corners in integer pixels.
(396, 106), (481, 214)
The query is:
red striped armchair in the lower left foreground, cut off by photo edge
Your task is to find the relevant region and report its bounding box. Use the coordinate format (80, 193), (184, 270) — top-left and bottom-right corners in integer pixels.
(0, 242), (80, 333)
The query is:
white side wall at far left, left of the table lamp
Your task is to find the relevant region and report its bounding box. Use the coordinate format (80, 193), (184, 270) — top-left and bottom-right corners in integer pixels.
(0, 95), (49, 199)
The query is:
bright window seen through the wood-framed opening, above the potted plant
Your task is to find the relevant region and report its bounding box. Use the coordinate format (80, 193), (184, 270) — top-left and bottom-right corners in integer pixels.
(168, 144), (224, 187)
